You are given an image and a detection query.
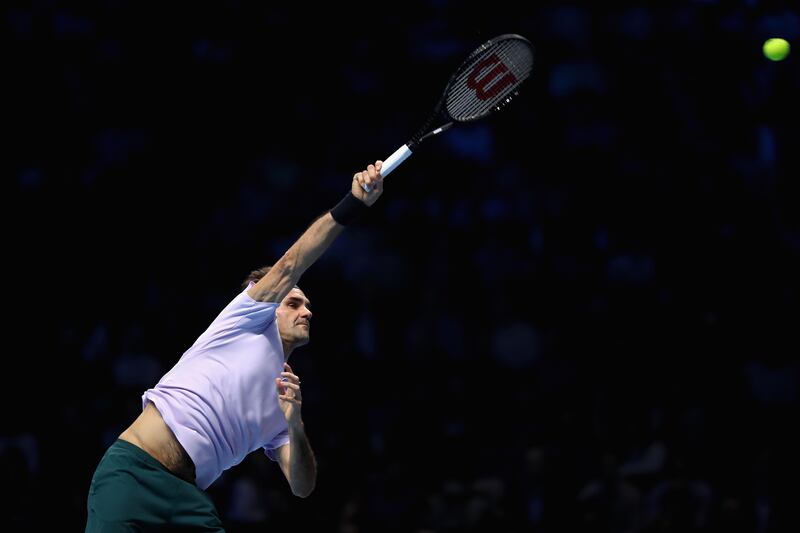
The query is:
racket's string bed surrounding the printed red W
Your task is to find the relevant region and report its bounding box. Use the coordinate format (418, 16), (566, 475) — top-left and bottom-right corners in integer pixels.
(447, 39), (533, 121)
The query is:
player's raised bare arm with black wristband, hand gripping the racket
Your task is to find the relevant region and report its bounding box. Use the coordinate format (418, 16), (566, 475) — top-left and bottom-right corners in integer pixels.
(248, 161), (383, 302)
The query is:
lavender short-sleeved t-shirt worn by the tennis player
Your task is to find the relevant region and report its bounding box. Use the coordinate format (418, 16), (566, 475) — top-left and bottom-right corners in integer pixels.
(142, 283), (289, 489)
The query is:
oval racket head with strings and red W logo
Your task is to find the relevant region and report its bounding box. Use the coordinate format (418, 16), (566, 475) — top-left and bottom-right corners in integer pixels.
(442, 33), (533, 122)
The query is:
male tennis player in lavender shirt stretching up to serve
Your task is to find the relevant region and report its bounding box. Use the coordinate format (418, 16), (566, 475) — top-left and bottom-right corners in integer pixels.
(86, 161), (383, 532)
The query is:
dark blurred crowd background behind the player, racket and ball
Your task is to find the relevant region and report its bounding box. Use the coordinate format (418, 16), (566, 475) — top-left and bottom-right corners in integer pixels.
(0, 0), (800, 533)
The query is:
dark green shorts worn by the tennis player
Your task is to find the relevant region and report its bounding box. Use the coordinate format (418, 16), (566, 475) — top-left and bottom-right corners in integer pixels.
(86, 439), (224, 532)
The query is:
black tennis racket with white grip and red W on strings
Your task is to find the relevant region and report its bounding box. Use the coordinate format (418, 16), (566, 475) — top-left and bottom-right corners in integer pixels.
(362, 33), (533, 192)
